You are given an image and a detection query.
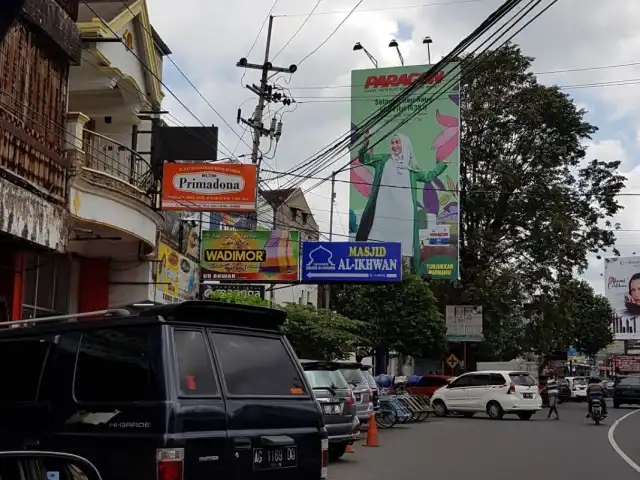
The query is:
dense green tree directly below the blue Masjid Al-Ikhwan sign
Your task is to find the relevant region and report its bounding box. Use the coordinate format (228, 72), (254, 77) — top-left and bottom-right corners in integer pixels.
(331, 273), (446, 357)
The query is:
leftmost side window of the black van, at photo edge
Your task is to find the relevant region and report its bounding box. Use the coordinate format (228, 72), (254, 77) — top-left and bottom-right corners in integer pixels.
(0, 339), (49, 403)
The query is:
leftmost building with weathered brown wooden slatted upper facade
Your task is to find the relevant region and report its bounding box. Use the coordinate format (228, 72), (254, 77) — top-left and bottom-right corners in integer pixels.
(0, 0), (81, 320)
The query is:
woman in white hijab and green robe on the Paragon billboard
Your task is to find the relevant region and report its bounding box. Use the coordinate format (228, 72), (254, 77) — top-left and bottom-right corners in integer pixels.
(356, 134), (447, 275)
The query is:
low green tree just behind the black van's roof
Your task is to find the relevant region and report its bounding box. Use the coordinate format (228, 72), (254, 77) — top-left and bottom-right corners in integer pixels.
(206, 292), (368, 360)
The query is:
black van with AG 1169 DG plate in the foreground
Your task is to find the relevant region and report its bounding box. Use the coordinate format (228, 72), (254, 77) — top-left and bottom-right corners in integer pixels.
(0, 301), (328, 480)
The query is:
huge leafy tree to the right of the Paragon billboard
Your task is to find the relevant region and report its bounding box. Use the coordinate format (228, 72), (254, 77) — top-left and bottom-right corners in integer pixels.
(433, 45), (625, 358)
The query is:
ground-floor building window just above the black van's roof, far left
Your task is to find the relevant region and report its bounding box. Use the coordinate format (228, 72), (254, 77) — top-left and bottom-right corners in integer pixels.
(22, 254), (71, 319)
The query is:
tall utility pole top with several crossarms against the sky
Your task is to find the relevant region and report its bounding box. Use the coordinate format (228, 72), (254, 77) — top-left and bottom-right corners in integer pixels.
(236, 16), (298, 164)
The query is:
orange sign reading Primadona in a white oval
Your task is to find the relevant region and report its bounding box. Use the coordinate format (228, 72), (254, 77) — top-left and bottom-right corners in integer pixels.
(162, 163), (257, 212)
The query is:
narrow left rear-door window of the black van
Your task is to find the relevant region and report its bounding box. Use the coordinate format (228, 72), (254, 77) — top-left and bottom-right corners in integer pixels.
(174, 330), (218, 396)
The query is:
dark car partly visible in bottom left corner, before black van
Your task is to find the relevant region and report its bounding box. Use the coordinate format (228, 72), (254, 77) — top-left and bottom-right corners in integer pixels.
(0, 450), (103, 480)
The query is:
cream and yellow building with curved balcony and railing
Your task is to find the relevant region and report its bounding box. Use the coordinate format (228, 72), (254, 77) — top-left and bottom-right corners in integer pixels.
(66, 0), (173, 312)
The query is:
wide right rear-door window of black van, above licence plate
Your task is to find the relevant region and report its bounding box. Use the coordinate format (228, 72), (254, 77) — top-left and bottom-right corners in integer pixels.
(212, 333), (306, 396)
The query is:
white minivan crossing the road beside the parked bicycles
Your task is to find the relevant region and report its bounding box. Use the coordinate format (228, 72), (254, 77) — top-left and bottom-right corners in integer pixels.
(431, 370), (542, 420)
